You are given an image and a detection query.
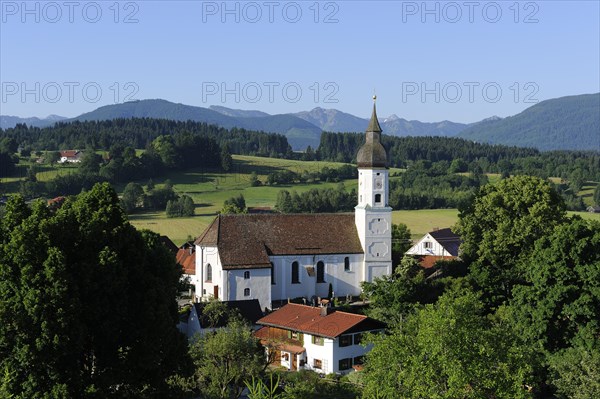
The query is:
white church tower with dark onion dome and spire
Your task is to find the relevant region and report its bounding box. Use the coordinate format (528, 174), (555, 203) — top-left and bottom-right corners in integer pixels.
(354, 96), (392, 281)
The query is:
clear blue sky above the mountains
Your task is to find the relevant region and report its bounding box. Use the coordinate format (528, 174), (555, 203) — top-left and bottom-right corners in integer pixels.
(0, 0), (600, 122)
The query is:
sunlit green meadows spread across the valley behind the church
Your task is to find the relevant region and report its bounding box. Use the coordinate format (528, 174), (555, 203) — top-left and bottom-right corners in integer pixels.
(2, 155), (600, 245)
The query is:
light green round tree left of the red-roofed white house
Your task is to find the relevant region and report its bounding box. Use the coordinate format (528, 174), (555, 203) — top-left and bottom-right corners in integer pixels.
(185, 320), (267, 399)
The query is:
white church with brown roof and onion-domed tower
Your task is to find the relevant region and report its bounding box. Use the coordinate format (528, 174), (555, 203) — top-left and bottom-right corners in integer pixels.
(191, 97), (392, 309)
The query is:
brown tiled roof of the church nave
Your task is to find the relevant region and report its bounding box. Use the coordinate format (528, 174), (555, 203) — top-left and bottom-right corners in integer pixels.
(196, 213), (363, 270)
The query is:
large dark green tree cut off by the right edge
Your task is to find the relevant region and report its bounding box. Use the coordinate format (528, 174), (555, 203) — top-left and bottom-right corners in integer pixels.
(511, 218), (600, 353)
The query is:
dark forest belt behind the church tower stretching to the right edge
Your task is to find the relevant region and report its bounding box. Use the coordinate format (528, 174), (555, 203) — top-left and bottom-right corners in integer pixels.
(315, 132), (600, 182)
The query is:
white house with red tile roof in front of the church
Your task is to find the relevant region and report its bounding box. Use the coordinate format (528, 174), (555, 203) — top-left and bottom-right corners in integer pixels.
(255, 303), (385, 374)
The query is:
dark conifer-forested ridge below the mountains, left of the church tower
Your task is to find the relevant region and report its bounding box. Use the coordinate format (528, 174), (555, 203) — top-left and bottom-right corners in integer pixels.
(0, 118), (292, 157)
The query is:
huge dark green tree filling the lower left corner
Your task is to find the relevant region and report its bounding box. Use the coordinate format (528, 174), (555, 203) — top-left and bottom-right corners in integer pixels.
(0, 184), (186, 398)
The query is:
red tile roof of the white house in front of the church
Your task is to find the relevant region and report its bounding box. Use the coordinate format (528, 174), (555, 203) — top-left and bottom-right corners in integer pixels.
(257, 303), (385, 338)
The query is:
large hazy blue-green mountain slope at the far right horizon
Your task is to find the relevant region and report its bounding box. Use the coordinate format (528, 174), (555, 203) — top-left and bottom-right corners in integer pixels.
(458, 93), (600, 151)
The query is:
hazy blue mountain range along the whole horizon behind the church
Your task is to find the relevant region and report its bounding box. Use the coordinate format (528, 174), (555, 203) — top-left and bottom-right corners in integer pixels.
(0, 93), (600, 151)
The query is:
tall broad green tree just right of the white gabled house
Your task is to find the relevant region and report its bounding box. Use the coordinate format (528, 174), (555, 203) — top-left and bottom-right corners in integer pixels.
(457, 176), (566, 306)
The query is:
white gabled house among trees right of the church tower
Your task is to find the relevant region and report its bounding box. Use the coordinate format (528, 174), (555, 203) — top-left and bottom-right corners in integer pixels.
(405, 228), (460, 269)
